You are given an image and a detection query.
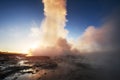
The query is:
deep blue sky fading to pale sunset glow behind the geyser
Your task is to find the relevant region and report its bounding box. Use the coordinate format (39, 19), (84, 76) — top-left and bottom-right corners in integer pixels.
(0, 0), (120, 52)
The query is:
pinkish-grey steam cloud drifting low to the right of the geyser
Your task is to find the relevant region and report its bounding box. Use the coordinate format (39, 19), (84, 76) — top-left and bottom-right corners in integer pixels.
(76, 11), (120, 52)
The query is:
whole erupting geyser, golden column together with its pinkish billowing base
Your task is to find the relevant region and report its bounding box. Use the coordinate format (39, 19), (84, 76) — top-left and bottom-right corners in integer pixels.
(32, 0), (74, 55)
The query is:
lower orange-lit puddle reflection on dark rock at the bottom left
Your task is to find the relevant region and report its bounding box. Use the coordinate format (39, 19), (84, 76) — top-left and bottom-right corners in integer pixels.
(4, 68), (48, 80)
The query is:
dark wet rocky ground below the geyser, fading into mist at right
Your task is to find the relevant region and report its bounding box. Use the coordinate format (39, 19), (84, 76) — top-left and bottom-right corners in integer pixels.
(0, 55), (100, 80)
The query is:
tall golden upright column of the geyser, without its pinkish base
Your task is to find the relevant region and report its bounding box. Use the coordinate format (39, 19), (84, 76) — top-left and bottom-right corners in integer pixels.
(40, 0), (67, 46)
